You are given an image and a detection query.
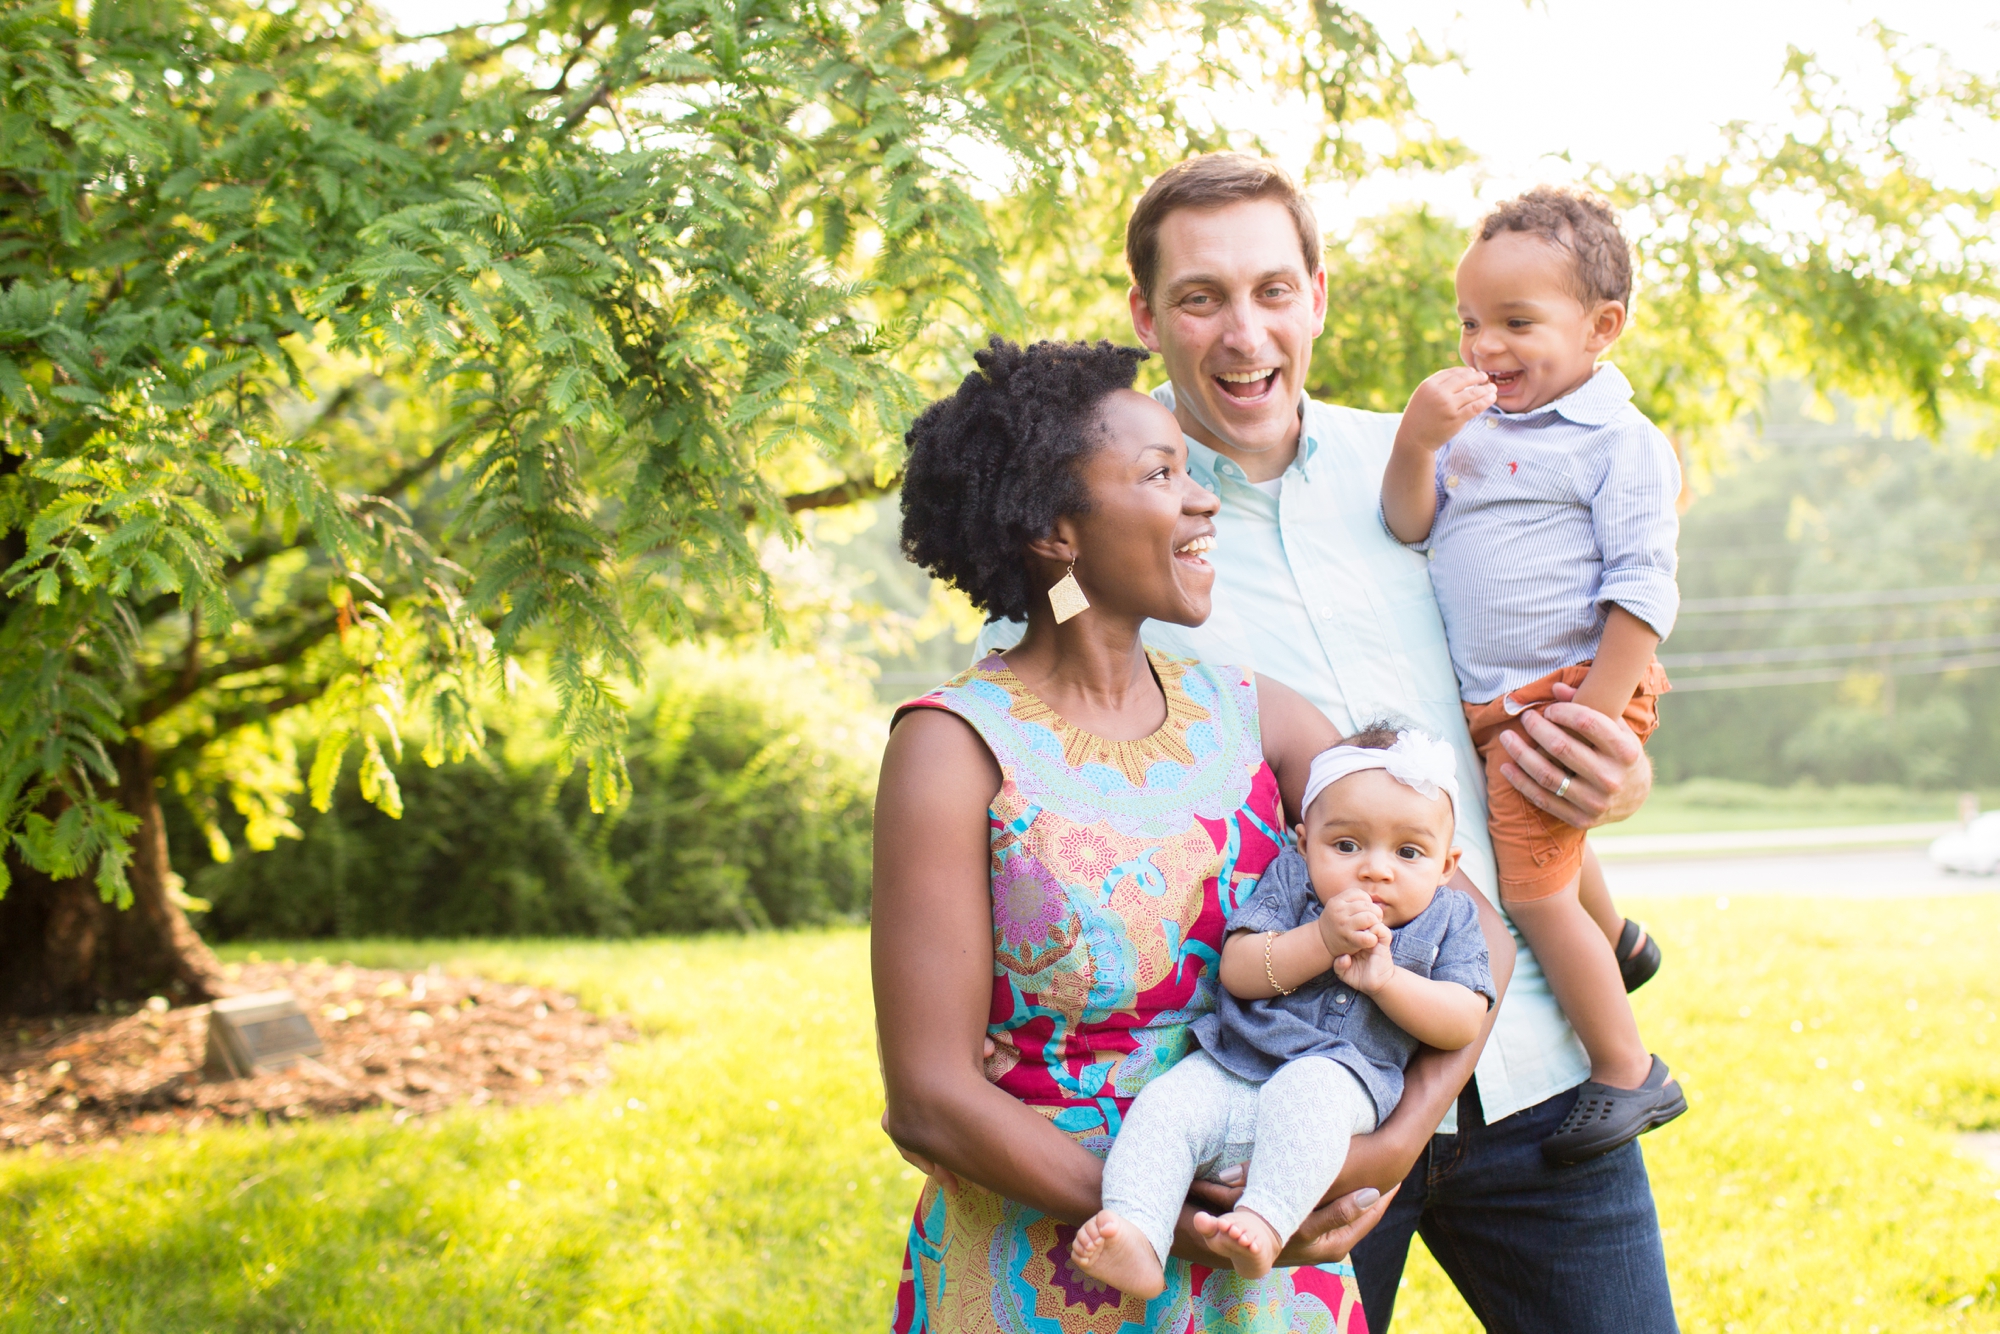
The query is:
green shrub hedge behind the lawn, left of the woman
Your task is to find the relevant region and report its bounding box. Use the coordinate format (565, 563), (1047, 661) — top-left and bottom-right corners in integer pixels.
(170, 650), (882, 940)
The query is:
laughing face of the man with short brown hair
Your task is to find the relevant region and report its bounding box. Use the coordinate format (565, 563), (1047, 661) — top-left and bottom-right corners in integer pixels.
(1130, 200), (1326, 480)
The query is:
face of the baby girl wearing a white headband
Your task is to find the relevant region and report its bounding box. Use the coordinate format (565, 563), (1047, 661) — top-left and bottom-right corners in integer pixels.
(1298, 768), (1458, 926)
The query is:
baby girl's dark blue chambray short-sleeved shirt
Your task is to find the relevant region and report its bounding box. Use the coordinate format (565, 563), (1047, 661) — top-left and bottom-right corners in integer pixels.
(1192, 848), (1494, 1124)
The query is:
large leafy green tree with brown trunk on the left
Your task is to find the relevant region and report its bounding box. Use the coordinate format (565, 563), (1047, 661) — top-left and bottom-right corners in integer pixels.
(0, 0), (1440, 1008)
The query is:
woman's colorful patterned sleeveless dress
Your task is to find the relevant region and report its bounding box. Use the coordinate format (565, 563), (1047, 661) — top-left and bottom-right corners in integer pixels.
(894, 654), (1366, 1334)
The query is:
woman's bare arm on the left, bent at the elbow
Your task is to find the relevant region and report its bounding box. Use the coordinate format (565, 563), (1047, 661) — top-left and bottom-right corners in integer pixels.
(870, 708), (1102, 1224)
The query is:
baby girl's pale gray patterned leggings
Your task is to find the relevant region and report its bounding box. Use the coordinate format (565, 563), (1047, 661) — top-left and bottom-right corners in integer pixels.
(1104, 1052), (1376, 1262)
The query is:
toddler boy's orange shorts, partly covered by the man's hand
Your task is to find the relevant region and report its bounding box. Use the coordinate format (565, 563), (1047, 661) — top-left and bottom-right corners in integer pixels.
(1466, 662), (1672, 902)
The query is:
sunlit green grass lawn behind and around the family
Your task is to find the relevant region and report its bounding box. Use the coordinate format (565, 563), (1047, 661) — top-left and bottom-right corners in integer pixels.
(0, 896), (2000, 1334)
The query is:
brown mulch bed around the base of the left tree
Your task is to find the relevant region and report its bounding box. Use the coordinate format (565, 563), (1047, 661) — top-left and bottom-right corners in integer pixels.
(0, 960), (634, 1150)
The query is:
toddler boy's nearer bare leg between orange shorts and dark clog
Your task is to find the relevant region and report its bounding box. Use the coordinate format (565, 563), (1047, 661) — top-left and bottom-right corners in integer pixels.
(1502, 880), (1652, 1088)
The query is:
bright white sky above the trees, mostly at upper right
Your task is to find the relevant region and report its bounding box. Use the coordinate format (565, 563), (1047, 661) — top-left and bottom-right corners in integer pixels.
(384, 0), (2000, 234)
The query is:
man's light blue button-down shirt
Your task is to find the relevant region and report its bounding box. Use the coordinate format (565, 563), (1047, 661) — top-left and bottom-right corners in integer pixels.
(978, 386), (1590, 1134)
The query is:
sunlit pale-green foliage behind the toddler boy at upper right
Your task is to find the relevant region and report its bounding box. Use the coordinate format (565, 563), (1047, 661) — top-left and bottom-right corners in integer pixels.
(1310, 26), (2000, 456)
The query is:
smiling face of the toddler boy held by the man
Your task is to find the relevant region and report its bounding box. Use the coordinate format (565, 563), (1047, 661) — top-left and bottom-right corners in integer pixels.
(1458, 232), (1626, 412)
